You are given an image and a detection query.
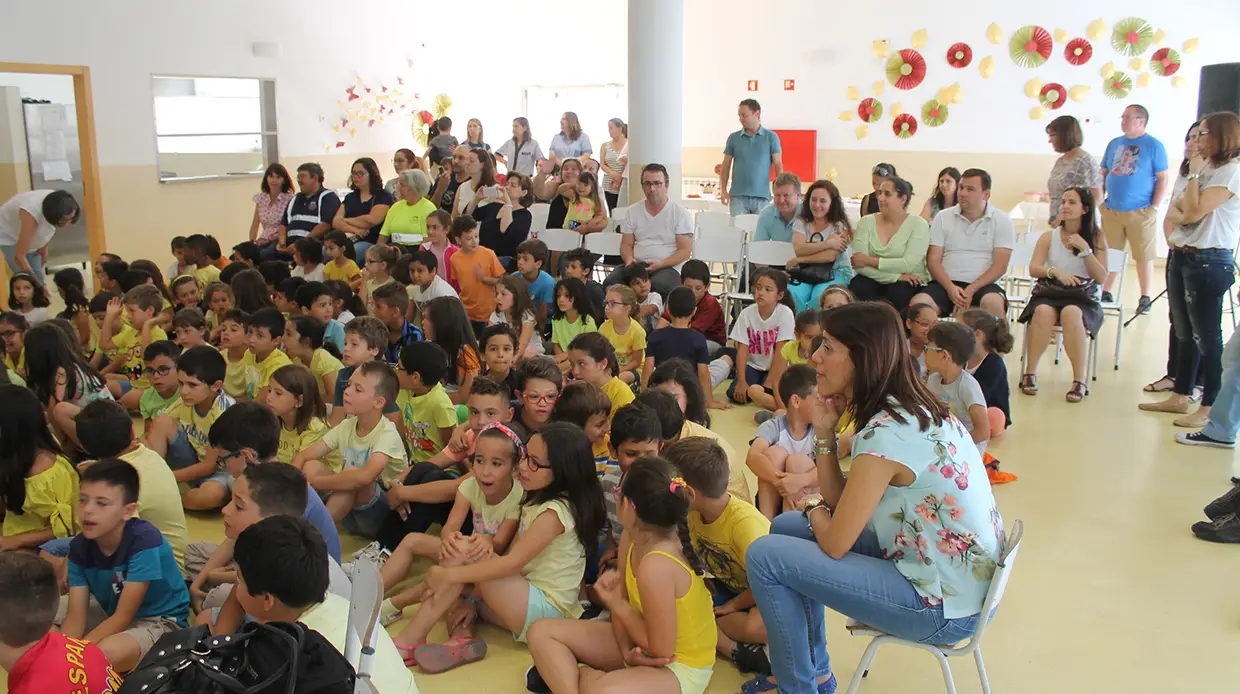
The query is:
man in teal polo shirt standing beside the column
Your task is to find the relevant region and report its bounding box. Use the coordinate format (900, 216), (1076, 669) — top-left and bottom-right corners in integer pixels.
(719, 99), (784, 216)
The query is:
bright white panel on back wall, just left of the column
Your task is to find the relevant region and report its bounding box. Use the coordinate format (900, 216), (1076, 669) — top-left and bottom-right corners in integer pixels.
(521, 84), (629, 149)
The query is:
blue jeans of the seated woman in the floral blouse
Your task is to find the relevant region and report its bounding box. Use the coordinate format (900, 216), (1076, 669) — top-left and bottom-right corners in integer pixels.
(745, 511), (980, 694)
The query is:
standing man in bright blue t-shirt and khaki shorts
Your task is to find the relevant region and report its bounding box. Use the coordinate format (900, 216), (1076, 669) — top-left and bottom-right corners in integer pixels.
(1099, 104), (1167, 314)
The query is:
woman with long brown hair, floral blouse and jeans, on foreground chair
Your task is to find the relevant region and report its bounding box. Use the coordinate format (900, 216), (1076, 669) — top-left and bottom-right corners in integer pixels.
(746, 302), (1003, 692)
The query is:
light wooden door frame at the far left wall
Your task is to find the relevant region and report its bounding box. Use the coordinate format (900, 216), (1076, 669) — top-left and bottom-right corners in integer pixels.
(0, 62), (107, 295)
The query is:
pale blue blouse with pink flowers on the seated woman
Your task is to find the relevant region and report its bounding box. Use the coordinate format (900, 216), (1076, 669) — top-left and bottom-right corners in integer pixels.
(853, 401), (1003, 620)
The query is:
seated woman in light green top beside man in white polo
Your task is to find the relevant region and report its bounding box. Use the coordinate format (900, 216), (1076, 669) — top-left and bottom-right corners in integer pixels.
(848, 176), (930, 311)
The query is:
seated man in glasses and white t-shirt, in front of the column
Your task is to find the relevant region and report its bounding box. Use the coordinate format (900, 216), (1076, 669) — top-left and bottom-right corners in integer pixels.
(603, 164), (693, 301)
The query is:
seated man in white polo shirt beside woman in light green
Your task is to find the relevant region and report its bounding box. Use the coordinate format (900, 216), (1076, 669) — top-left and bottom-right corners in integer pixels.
(911, 169), (1016, 318)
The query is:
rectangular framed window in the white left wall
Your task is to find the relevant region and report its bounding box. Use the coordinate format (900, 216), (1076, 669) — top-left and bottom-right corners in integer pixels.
(151, 76), (279, 181)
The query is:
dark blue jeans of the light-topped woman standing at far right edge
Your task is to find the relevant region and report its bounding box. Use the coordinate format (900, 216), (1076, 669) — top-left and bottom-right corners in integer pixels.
(1167, 248), (1235, 406)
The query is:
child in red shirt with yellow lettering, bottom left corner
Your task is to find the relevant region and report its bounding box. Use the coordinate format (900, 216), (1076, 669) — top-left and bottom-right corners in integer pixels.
(0, 551), (120, 694)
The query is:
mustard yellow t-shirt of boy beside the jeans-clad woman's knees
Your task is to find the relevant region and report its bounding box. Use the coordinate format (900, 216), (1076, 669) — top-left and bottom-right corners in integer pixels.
(689, 497), (771, 595)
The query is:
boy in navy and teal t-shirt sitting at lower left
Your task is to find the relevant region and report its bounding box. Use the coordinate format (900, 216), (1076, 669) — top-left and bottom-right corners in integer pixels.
(61, 459), (190, 672)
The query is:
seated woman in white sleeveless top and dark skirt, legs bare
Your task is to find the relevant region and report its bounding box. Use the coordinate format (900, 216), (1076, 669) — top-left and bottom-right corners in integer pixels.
(1018, 188), (1106, 403)
